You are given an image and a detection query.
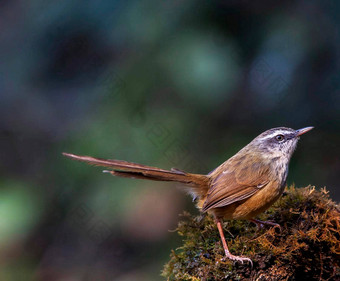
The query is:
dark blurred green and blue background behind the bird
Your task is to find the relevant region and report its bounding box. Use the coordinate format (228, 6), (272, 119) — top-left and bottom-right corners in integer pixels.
(0, 0), (340, 281)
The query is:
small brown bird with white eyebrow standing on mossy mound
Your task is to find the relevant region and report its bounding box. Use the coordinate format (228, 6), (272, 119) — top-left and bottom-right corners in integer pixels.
(63, 127), (313, 263)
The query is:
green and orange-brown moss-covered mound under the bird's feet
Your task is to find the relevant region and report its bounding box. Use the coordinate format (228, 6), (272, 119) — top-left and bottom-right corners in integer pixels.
(162, 187), (340, 280)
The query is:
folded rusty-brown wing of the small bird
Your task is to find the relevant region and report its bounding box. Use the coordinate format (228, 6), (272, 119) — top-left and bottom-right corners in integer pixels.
(202, 161), (269, 212)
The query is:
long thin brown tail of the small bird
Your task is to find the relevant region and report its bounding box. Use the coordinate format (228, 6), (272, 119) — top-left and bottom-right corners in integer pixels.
(63, 152), (209, 195)
